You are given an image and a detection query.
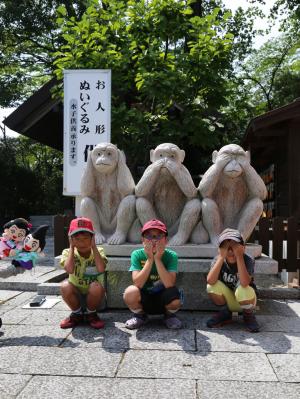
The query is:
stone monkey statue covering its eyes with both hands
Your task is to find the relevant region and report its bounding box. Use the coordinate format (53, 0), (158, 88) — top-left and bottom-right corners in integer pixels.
(199, 144), (267, 244)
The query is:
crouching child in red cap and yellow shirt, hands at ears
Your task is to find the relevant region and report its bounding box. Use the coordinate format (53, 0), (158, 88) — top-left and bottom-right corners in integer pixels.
(60, 217), (107, 329)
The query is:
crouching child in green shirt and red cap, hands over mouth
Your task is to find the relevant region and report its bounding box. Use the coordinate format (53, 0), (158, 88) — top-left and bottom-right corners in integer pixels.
(124, 219), (181, 329)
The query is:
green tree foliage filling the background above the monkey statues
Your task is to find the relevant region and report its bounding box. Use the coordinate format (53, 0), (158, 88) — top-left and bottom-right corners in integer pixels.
(0, 0), (299, 200)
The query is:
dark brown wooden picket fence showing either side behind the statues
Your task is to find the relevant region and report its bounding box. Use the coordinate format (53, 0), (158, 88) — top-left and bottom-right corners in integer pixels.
(53, 215), (300, 272)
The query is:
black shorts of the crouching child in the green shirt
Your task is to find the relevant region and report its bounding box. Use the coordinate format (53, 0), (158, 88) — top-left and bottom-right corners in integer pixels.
(140, 287), (180, 314)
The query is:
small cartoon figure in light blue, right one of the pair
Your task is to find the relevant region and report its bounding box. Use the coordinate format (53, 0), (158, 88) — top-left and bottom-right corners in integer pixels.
(11, 225), (49, 270)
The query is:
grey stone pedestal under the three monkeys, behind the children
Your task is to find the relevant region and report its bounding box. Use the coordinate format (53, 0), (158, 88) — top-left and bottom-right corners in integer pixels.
(51, 244), (278, 310)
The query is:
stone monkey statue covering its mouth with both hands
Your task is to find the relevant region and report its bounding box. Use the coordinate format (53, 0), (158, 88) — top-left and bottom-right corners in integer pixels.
(135, 143), (201, 245)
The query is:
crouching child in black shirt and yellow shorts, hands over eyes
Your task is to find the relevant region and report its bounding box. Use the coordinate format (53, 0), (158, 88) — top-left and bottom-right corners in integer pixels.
(207, 229), (259, 332)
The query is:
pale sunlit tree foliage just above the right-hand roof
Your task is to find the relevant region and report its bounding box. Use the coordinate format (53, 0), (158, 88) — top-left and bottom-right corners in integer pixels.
(224, 27), (300, 141)
